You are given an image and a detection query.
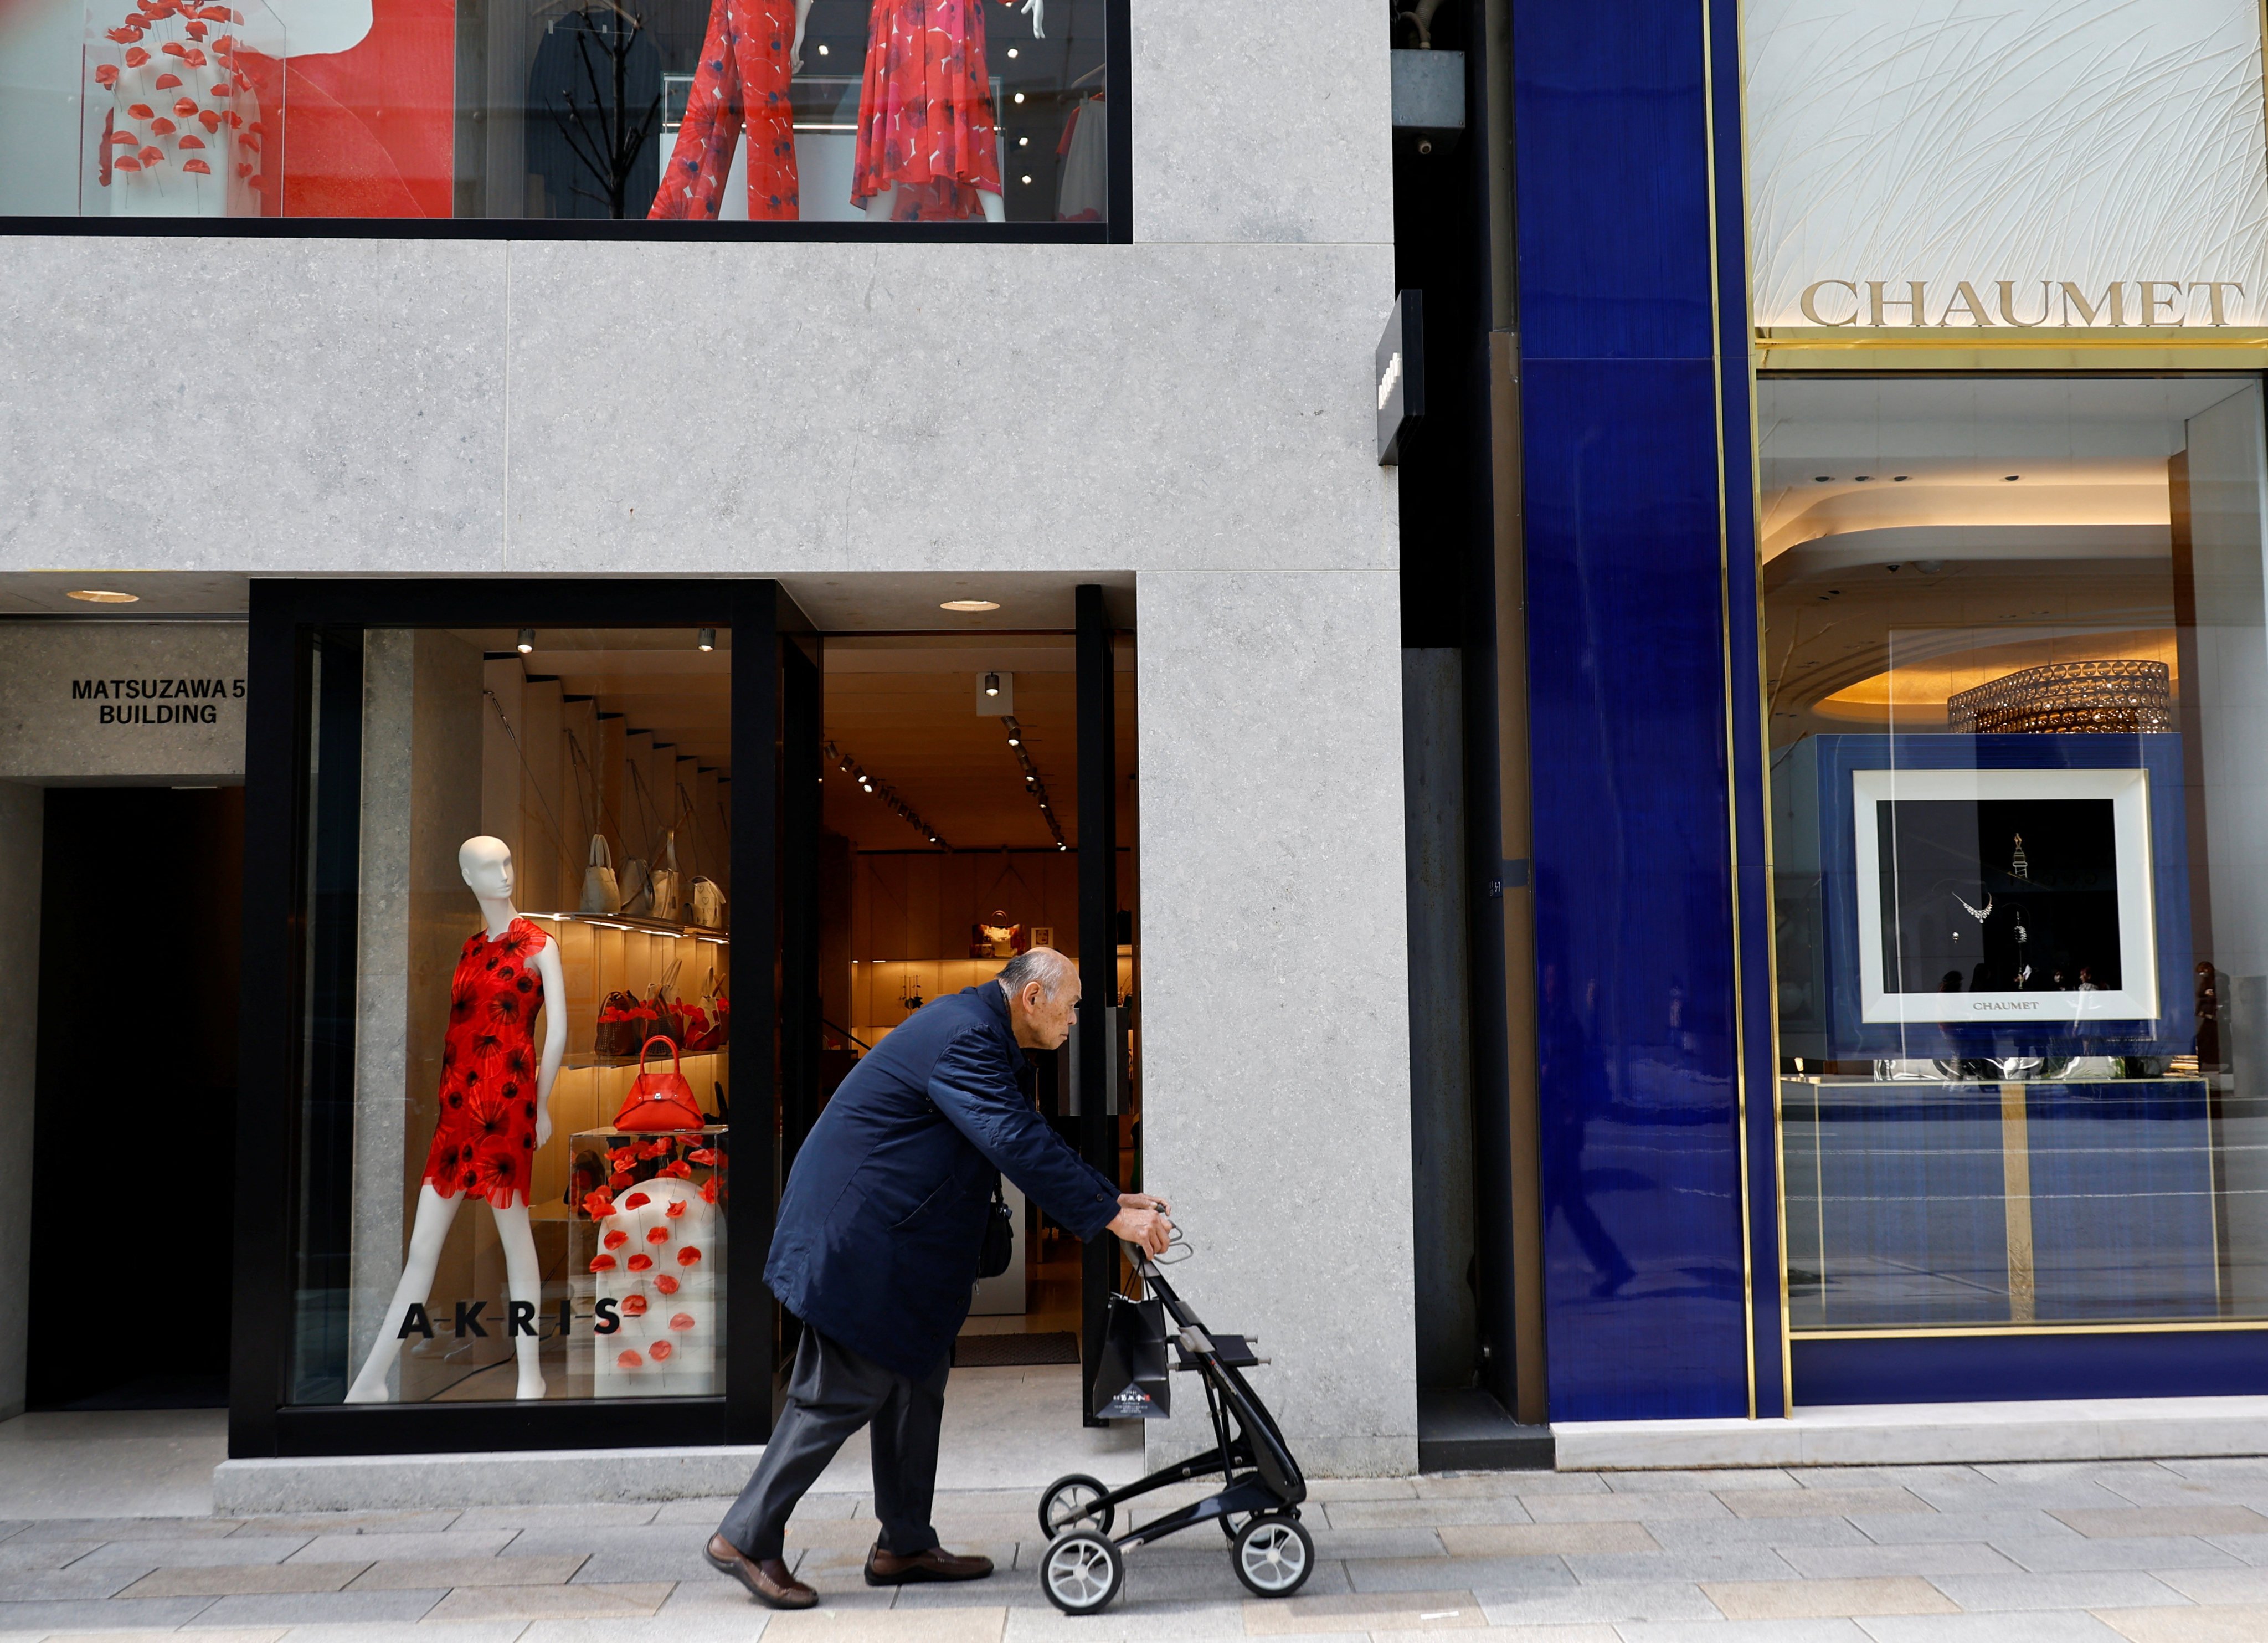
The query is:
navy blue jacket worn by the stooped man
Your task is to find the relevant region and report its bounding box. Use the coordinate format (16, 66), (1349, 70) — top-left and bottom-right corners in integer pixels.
(764, 983), (1118, 1380)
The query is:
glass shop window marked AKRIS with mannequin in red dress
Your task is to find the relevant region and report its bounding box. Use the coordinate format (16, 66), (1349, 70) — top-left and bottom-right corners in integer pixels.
(290, 629), (733, 1405)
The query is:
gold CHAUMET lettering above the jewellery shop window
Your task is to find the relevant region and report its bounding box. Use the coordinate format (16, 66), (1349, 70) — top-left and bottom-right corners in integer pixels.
(1796, 279), (2245, 331)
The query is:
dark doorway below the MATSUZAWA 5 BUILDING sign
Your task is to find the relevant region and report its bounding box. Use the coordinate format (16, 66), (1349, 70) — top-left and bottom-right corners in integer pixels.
(25, 788), (245, 1409)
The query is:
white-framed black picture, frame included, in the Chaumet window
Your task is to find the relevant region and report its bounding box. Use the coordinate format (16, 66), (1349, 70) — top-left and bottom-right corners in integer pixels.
(1851, 769), (2157, 1024)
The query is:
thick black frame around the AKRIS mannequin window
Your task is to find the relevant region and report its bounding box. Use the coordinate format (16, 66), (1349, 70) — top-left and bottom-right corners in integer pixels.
(229, 577), (812, 1459)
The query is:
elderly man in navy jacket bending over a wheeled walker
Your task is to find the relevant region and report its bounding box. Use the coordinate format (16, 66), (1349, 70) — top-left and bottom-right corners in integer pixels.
(706, 946), (1172, 1609)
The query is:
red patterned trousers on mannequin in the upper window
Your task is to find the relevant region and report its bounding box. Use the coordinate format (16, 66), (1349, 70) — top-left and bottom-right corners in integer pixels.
(646, 0), (798, 222)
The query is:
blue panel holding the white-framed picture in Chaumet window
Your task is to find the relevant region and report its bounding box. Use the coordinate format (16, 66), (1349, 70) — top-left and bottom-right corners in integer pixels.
(1776, 733), (2195, 1060)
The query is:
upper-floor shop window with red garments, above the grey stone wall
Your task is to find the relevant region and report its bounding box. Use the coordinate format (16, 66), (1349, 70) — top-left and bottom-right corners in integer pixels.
(0, 0), (1109, 222)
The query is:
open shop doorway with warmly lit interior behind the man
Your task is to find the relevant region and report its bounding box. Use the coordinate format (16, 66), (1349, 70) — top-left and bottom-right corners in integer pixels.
(783, 603), (1141, 1425)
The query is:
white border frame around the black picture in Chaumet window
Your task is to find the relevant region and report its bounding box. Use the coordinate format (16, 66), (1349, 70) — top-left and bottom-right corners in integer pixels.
(1851, 769), (2159, 1026)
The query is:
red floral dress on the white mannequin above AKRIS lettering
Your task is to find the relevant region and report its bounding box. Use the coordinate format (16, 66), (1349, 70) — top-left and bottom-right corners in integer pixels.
(424, 919), (551, 1210)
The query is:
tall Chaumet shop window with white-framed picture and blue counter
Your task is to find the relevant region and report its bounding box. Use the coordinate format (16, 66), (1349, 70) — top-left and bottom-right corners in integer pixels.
(1758, 377), (2268, 1332)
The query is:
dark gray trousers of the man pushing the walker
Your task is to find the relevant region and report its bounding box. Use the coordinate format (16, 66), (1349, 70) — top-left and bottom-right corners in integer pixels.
(717, 1323), (953, 1559)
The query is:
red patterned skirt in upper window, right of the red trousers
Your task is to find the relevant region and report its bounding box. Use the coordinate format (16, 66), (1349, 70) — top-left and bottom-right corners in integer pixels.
(851, 0), (1000, 222)
